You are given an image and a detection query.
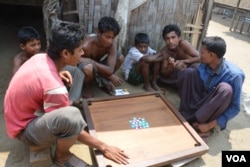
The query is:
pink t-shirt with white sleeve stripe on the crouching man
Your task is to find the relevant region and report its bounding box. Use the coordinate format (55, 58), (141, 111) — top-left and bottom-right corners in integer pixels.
(4, 53), (70, 138)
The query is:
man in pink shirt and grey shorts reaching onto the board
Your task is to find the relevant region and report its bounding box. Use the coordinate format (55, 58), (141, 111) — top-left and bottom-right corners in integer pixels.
(4, 24), (128, 166)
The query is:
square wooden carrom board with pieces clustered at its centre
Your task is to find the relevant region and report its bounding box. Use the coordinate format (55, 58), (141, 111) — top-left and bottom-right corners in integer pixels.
(83, 92), (209, 167)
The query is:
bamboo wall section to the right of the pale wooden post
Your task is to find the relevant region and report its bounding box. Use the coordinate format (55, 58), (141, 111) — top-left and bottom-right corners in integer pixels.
(123, 0), (207, 51)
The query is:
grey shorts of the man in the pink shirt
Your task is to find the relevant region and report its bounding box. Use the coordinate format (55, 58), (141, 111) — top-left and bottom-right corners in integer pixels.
(17, 106), (87, 146)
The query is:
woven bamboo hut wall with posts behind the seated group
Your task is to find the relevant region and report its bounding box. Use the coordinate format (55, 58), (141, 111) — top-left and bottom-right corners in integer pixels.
(43, 0), (214, 54)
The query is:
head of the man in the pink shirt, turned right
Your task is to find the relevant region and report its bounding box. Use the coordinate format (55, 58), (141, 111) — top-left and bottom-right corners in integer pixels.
(47, 23), (84, 66)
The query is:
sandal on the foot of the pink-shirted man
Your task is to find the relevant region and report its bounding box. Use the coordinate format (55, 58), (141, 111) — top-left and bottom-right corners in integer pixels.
(55, 154), (90, 167)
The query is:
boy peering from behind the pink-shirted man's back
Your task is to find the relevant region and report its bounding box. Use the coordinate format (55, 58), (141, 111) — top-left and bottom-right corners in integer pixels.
(12, 27), (41, 75)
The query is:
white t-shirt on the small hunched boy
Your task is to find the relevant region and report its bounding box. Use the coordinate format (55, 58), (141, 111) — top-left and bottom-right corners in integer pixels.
(123, 47), (156, 80)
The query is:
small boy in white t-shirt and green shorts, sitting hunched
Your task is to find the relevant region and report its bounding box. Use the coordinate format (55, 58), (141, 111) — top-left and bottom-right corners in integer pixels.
(123, 33), (160, 91)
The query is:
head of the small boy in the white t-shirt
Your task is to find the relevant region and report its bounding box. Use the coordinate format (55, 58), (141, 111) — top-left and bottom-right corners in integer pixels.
(134, 33), (149, 54)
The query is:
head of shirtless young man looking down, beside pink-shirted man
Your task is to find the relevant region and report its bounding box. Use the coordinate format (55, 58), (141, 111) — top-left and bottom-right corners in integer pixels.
(97, 16), (121, 47)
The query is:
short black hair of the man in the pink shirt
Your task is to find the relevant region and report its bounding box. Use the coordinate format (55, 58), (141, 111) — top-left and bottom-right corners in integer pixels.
(47, 23), (84, 60)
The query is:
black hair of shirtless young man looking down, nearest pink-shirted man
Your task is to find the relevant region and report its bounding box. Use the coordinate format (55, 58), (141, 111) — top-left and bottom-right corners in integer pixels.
(98, 16), (121, 36)
